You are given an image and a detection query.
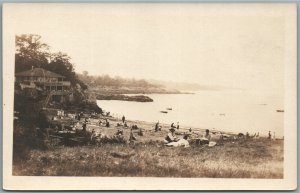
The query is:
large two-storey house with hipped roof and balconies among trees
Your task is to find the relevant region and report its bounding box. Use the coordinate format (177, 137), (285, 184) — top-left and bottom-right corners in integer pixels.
(15, 68), (71, 91)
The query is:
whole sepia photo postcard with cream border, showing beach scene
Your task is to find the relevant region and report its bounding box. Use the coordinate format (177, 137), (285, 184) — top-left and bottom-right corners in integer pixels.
(3, 3), (297, 190)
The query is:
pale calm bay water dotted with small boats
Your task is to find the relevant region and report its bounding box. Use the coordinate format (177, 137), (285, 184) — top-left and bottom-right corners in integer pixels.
(97, 90), (284, 137)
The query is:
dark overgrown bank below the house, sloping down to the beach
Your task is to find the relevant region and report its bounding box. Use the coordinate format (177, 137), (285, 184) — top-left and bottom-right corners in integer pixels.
(14, 86), (102, 125)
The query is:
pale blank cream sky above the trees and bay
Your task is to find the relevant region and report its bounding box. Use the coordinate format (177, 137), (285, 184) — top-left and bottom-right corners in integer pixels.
(11, 4), (286, 93)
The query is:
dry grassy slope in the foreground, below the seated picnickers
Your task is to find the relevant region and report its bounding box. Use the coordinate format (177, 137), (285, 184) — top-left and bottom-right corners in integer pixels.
(13, 138), (283, 178)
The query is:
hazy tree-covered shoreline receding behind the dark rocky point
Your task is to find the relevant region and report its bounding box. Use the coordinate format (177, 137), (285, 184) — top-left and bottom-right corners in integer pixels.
(78, 73), (235, 94)
